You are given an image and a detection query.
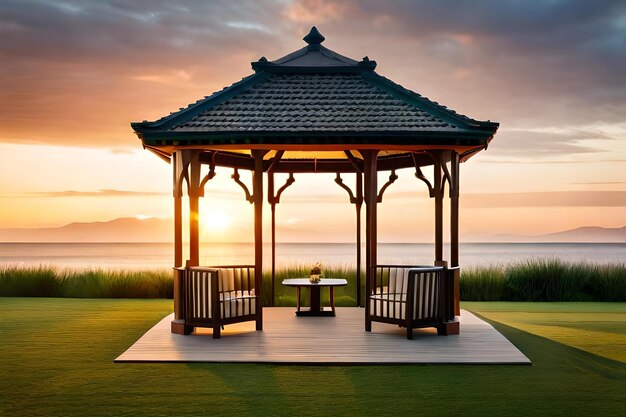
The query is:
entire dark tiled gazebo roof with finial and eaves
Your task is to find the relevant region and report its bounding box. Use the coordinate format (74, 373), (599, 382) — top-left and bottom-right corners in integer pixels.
(132, 27), (498, 151)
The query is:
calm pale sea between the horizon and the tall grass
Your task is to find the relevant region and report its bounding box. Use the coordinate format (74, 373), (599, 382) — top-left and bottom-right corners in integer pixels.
(0, 243), (626, 269)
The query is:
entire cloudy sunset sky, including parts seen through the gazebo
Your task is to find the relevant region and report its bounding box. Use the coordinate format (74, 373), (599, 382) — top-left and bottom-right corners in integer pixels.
(0, 0), (626, 242)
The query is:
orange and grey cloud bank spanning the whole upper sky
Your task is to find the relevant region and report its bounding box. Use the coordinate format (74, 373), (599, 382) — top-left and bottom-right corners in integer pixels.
(0, 0), (626, 153)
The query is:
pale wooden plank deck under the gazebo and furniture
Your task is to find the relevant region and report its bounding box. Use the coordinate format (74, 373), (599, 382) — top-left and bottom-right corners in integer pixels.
(115, 307), (530, 364)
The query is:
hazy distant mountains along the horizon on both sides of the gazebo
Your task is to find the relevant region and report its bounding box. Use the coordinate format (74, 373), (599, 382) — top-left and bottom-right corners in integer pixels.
(0, 217), (626, 243)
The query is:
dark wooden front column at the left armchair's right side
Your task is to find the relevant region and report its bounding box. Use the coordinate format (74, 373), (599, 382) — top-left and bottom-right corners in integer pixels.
(252, 150), (267, 330)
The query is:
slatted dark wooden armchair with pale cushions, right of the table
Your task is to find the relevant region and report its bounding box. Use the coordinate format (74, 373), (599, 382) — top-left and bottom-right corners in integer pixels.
(365, 265), (459, 339)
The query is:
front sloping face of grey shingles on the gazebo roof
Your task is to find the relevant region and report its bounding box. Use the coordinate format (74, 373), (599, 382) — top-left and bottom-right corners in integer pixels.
(171, 74), (458, 132)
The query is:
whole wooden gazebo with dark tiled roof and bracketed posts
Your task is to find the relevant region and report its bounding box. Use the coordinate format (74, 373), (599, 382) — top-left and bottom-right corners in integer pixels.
(131, 27), (499, 334)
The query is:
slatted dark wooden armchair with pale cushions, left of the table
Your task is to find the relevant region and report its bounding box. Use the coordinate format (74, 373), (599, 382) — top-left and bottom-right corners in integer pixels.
(178, 265), (262, 339)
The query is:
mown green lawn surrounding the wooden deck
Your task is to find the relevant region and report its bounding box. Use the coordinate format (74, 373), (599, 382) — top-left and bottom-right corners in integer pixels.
(0, 298), (626, 416)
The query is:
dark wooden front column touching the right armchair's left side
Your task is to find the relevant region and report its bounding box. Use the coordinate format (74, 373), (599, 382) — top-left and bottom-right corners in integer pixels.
(360, 150), (378, 332)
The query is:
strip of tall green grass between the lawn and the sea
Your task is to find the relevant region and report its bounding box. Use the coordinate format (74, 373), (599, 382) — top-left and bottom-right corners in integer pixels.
(0, 259), (626, 300)
